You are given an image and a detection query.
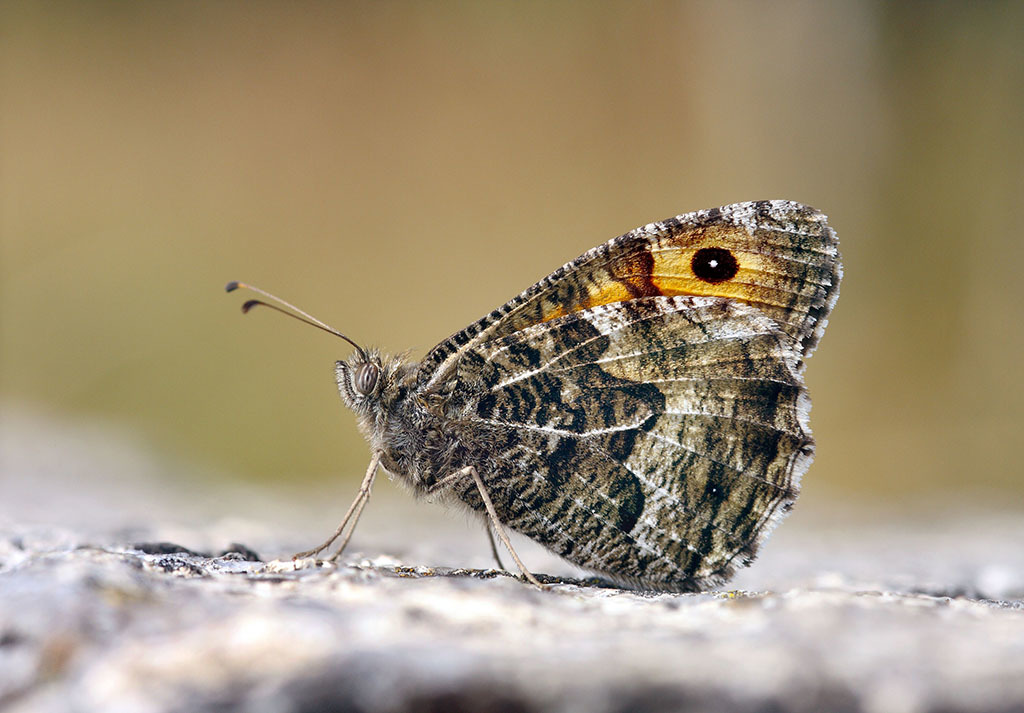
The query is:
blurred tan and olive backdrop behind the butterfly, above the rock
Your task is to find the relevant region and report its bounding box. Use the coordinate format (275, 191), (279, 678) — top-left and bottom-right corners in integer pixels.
(0, 0), (1024, 549)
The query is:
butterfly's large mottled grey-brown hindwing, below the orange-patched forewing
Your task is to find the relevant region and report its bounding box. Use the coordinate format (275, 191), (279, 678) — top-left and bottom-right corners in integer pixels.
(447, 296), (813, 590)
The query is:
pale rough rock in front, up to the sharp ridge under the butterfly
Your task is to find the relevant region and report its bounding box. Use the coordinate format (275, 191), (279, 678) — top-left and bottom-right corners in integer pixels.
(0, 528), (1024, 713)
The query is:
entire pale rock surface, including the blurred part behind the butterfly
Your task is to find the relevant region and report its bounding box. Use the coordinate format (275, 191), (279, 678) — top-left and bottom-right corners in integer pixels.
(0, 409), (1024, 713)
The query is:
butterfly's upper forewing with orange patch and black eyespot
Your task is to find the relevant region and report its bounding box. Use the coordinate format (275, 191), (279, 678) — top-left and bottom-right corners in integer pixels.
(420, 201), (842, 393)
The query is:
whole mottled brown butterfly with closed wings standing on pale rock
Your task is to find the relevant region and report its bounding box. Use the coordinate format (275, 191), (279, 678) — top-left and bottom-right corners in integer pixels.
(228, 201), (842, 591)
